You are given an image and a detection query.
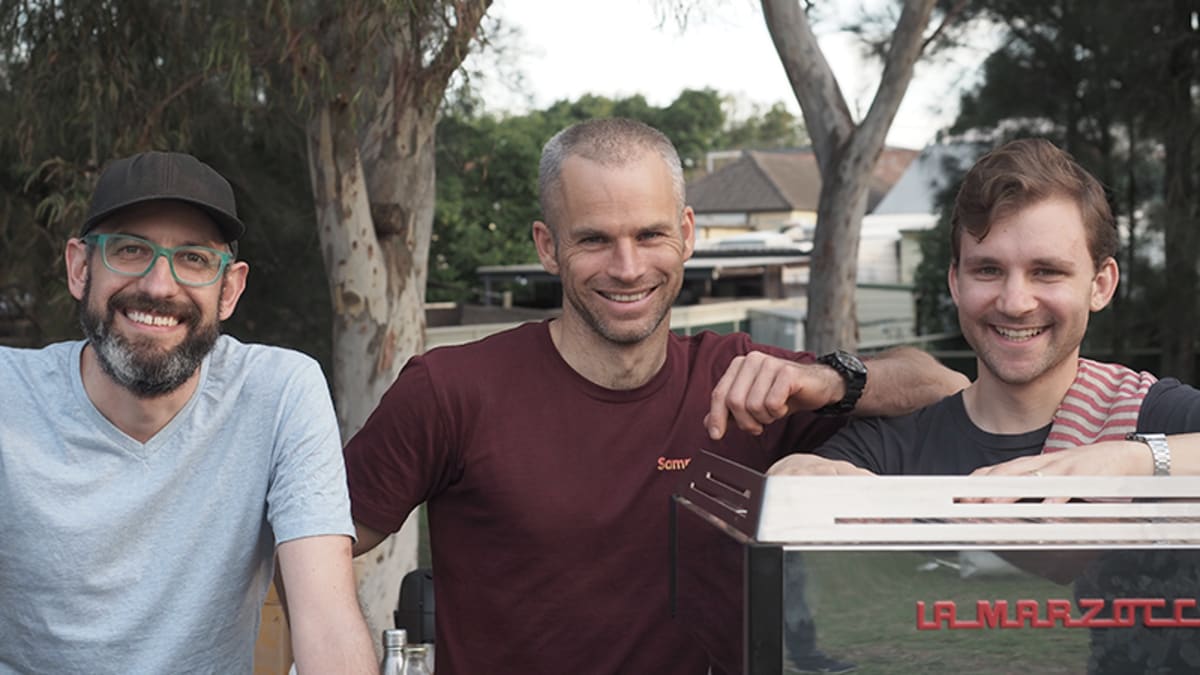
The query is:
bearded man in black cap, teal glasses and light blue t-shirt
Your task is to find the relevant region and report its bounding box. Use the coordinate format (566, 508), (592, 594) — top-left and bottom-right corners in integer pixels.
(0, 153), (376, 674)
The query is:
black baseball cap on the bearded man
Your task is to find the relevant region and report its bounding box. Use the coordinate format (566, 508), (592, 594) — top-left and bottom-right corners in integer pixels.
(79, 153), (246, 243)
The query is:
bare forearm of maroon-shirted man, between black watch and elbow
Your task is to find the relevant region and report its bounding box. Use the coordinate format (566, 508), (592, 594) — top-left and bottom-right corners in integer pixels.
(854, 347), (971, 416)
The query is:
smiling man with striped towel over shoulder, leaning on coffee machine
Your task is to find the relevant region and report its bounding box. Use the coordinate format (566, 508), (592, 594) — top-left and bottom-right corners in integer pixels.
(772, 141), (1200, 675)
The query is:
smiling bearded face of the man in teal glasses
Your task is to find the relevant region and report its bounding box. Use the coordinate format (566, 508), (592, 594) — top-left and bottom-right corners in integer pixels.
(67, 202), (247, 398)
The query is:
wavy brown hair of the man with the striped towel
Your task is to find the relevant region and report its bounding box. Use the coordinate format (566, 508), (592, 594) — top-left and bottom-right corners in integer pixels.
(950, 138), (1120, 269)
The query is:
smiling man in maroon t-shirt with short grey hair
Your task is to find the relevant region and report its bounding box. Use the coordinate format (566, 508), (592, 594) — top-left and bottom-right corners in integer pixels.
(346, 119), (966, 675)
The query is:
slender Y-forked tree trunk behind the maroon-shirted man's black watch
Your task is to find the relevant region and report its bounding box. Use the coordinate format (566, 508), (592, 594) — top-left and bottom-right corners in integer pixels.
(762, 0), (935, 353)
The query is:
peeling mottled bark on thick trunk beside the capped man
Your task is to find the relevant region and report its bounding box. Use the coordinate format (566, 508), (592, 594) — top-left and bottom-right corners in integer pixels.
(307, 0), (491, 647)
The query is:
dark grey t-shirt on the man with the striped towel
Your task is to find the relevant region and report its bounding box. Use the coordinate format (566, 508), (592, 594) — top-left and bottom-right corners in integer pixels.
(815, 378), (1200, 476)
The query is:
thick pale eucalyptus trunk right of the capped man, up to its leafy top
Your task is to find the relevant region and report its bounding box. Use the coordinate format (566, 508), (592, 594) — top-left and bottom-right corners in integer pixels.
(274, 0), (491, 629)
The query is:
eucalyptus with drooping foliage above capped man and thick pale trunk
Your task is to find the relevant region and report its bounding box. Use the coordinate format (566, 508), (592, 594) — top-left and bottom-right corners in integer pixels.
(0, 0), (491, 627)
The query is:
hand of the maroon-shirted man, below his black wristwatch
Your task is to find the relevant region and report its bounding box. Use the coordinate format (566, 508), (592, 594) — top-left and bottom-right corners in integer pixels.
(704, 352), (846, 441)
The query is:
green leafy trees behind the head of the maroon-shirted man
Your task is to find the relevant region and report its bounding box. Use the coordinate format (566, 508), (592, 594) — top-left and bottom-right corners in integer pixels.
(427, 89), (805, 301)
